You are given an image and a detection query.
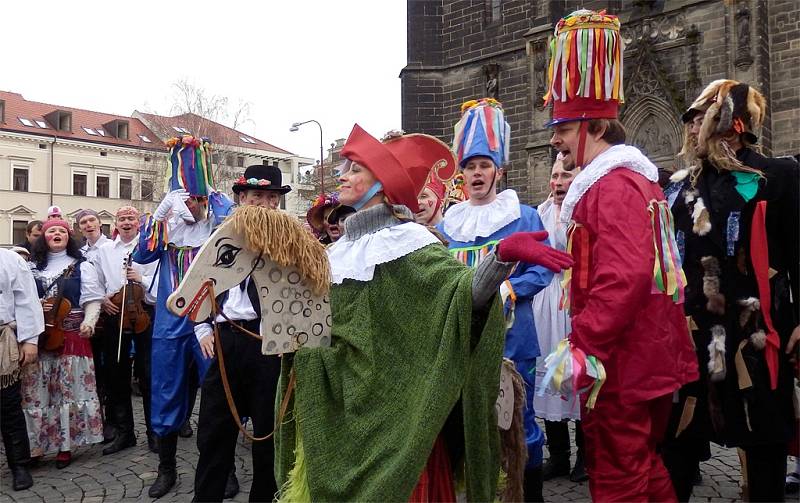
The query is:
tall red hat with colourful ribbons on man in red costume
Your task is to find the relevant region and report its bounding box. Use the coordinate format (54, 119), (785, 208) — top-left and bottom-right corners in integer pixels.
(544, 9), (625, 126)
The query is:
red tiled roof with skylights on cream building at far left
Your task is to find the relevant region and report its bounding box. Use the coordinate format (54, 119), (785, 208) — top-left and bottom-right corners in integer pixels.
(0, 91), (166, 150)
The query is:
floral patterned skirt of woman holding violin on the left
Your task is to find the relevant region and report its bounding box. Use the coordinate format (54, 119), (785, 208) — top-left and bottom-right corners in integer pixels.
(20, 331), (103, 456)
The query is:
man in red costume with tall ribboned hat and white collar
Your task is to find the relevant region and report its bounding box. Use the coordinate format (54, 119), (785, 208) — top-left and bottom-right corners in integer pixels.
(545, 10), (698, 501)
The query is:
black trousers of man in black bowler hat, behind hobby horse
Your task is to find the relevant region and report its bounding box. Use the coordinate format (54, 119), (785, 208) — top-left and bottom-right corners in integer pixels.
(194, 320), (281, 501)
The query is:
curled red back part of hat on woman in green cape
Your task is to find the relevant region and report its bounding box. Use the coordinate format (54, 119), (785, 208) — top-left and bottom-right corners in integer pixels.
(385, 133), (458, 204)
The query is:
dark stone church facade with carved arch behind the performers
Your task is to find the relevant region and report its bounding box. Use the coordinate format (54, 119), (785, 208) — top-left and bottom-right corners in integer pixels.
(400, 0), (800, 204)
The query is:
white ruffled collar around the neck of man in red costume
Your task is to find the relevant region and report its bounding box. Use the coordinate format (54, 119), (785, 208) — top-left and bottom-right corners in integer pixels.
(561, 145), (658, 222)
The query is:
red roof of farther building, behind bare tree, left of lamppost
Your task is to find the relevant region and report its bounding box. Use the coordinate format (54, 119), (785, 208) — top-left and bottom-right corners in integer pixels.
(134, 112), (294, 155)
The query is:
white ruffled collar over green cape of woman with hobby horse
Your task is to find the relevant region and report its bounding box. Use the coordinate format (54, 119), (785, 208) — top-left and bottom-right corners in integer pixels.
(326, 222), (439, 285)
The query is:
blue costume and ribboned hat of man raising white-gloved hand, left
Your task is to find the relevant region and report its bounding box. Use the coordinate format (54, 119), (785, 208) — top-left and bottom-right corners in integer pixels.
(133, 136), (233, 437)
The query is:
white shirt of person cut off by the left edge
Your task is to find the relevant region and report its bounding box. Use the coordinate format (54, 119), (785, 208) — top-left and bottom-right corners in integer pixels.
(0, 248), (44, 344)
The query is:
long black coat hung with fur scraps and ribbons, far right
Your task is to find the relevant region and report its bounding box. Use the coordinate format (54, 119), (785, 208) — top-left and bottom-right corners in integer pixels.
(672, 149), (800, 446)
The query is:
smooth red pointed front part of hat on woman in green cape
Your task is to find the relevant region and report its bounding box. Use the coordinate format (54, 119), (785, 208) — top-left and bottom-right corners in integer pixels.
(341, 124), (419, 213)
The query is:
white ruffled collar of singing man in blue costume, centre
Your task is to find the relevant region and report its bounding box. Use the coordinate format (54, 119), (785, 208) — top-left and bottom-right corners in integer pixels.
(444, 189), (521, 242)
